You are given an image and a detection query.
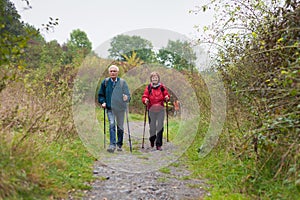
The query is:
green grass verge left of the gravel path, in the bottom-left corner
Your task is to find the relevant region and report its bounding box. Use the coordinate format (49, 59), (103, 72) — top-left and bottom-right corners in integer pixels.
(0, 139), (94, 199)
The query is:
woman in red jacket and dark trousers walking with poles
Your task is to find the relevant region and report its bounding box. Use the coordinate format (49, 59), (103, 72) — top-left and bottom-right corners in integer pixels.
(142, 72), (170, 151)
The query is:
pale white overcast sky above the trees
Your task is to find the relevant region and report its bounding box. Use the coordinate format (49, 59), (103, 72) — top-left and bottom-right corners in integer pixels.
(11, 0), (212, 49)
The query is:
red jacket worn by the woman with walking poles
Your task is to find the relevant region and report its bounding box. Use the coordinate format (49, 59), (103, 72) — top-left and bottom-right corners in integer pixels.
(142, 83), (170, 109)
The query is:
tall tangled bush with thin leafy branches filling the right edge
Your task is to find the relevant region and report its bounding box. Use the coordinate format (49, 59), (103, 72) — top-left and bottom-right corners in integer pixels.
(197, 0), (300, 199)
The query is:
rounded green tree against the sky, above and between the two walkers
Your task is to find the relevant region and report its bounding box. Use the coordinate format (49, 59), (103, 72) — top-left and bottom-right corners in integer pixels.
(108, 35), (155, 63)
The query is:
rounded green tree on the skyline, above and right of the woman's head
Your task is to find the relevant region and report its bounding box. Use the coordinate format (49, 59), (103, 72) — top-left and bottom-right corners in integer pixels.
(157, 40), (196, 71)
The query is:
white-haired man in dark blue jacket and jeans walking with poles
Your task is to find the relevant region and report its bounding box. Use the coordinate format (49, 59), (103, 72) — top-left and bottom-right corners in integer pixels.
(98, 65), (130, 153)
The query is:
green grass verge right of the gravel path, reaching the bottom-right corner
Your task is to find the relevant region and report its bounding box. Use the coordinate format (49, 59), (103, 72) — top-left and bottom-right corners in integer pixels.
(181, 119), (300, 200)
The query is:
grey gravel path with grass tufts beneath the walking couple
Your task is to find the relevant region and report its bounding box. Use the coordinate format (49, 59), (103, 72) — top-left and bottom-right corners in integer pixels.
(83, 122), (210, 200)
